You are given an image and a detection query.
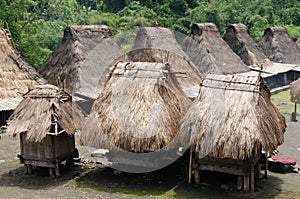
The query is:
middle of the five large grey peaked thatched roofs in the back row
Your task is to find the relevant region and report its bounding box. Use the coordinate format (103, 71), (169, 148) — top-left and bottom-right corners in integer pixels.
(183, 23), (250, 74)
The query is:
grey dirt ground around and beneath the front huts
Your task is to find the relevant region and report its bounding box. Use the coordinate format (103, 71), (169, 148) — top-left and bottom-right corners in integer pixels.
(0, 115), (300, 199)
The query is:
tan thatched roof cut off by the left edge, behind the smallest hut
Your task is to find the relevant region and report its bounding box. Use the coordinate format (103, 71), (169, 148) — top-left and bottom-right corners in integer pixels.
(0, 28), (46, 99)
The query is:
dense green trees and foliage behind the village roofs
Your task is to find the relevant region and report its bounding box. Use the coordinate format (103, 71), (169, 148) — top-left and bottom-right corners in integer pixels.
(0, 0), (300, 68)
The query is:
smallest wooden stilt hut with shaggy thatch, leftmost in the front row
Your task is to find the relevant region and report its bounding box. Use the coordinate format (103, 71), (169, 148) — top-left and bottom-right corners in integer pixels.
(7, 84), (83, 176)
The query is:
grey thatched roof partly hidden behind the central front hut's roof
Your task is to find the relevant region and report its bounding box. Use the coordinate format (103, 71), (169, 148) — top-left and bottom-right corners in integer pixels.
(128, 27), (202, 98)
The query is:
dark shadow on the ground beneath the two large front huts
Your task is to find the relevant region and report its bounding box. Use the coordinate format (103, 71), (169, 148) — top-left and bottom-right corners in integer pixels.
(75, 155), (283, 199)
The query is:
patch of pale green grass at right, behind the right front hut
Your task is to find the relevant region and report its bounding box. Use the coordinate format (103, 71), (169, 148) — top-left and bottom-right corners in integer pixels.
(271, 89), (300, 114)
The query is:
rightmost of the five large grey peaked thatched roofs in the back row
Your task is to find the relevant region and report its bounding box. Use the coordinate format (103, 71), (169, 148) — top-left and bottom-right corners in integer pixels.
(258, 27), (300, 65)
